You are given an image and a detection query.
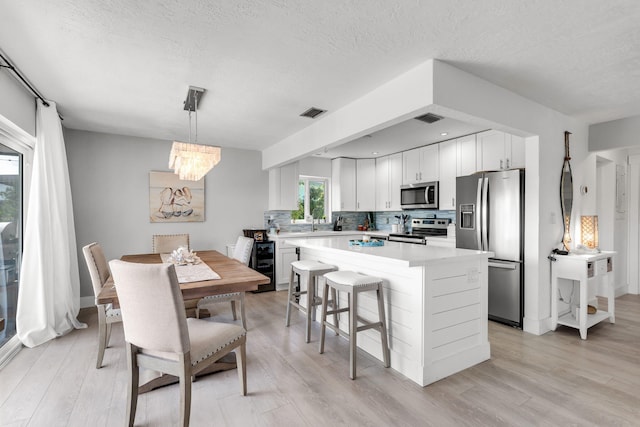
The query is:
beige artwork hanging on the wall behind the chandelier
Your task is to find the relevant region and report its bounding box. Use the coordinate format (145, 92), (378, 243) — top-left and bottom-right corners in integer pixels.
(149, 171), (204, 222)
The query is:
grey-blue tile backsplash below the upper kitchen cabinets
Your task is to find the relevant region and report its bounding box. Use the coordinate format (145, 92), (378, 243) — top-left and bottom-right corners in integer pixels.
(264, 209), (456, 232)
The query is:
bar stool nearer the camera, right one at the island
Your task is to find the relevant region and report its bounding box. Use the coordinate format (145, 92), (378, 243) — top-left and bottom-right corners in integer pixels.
(320, 271), (389, 380)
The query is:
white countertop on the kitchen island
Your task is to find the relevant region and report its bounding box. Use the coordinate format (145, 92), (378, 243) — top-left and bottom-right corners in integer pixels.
(285, 236), (493, 267)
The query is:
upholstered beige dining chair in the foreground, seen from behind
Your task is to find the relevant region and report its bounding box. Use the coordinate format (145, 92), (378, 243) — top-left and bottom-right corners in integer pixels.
(109, 260), (247, 426)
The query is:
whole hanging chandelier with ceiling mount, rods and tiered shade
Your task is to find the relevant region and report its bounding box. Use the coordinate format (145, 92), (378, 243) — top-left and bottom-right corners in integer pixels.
(169, 86), (221, 181)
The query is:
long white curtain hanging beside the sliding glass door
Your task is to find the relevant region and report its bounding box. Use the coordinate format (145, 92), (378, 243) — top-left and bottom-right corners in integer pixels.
(16, 101), (87, 347)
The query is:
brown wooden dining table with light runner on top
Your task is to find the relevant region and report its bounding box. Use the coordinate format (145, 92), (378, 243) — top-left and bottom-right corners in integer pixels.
(96, 250), (271, 393)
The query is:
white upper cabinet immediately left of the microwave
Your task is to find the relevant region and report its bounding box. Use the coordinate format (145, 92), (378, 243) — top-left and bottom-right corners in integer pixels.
(376, 153), (402, 211)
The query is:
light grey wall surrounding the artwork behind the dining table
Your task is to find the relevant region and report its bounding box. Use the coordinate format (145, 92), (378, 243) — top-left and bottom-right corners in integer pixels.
(65, 129), (268, 297)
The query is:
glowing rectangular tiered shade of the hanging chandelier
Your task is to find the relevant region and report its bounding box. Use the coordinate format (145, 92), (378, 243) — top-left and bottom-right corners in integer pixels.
(169, 141), (221, 181)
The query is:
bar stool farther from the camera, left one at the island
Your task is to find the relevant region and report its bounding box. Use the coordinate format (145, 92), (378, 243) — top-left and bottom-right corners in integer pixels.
(286, 260), (338, 342)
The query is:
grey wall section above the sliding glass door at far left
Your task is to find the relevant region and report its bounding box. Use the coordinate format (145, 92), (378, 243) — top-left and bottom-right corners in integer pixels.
(0, 68), (36, 136)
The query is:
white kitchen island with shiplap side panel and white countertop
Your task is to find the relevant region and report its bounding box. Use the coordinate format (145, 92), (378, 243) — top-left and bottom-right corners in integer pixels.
(286, 237), (493, 386)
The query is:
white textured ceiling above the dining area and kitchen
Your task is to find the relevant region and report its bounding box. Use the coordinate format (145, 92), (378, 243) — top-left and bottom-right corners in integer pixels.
(0, 0), (640, 149)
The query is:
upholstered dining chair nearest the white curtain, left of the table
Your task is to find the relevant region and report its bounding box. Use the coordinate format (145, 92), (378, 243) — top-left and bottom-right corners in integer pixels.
(82, 242), (122, 369)
